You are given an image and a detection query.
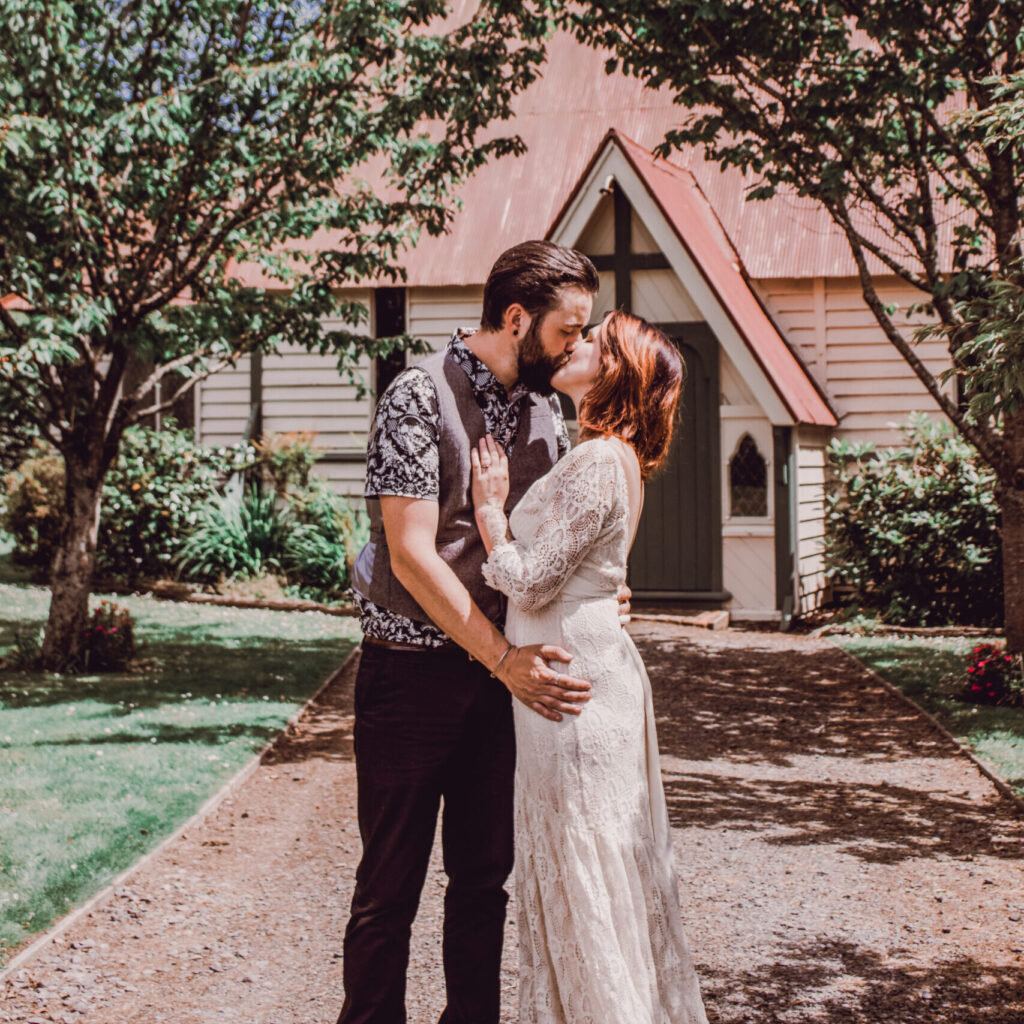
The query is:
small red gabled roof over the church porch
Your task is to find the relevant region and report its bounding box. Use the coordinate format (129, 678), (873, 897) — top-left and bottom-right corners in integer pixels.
(573, 130), (837, 427)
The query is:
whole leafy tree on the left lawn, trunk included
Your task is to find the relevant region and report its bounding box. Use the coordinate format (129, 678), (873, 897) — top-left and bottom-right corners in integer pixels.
(0, 0), (544, 669)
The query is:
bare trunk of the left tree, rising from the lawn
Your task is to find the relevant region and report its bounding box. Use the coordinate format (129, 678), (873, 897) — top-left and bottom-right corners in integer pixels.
(42, 453), (103, 672)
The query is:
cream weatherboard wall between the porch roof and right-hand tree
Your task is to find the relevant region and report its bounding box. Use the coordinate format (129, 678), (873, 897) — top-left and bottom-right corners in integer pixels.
(756, 278), (949, 444)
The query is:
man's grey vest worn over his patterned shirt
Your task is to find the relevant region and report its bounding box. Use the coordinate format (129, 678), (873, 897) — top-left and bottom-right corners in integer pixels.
(352, 352), (558, 623)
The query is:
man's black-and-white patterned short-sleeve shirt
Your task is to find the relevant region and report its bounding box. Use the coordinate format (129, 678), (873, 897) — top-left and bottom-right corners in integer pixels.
(356, 328), (569, 647)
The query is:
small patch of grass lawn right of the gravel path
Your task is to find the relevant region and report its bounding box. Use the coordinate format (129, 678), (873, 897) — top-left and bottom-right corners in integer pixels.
(833, 637), (1024, 797)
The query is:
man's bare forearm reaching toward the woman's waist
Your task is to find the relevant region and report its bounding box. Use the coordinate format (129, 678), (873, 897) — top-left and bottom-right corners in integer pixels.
(391, 550), (508, 669)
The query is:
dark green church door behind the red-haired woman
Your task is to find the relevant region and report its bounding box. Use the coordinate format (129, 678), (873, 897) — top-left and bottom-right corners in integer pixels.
(629, 324), (728, 602)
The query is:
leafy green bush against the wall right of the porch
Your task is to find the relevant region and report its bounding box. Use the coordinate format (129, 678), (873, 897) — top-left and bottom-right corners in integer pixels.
(824, 416), (1002, 626)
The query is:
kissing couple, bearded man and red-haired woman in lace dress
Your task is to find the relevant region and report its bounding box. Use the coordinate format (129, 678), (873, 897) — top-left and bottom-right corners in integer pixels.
(338, 242), (707, 1024)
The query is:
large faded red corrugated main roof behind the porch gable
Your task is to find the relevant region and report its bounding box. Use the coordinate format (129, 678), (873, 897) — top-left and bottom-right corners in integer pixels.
(228, 27), (962, 286)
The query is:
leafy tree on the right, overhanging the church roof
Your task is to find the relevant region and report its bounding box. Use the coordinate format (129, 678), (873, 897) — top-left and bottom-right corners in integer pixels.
(541, 0), (1024, 651)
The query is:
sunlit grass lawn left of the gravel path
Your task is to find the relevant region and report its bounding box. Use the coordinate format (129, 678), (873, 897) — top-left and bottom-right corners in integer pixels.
(0, 584), (359, 965)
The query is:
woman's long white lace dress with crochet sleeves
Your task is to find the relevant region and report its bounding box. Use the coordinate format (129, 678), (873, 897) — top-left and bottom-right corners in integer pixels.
(483, 439), (707, 1024)
